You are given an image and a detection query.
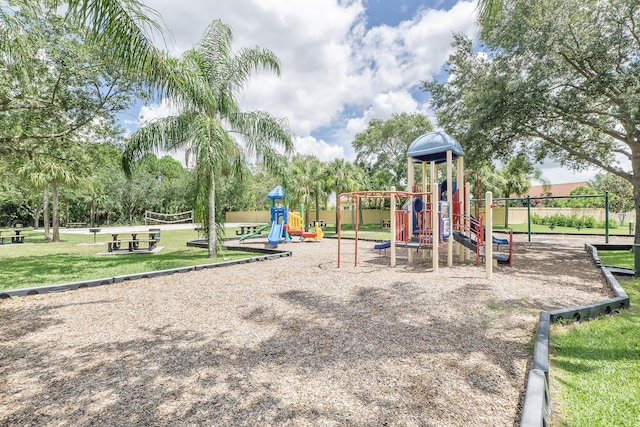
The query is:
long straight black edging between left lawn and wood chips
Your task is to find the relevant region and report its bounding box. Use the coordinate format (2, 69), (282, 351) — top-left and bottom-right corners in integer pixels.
(0, 246), (292, 300)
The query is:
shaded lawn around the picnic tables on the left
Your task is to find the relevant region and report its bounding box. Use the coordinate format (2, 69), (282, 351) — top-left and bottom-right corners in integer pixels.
(0, 230), (254, 290)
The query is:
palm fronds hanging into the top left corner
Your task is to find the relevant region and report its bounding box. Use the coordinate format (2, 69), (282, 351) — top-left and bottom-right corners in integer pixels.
(0, 0), (212, 130)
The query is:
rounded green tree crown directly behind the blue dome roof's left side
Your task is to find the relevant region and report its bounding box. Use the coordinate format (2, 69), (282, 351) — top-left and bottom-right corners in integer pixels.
(351, 113), (433, 188)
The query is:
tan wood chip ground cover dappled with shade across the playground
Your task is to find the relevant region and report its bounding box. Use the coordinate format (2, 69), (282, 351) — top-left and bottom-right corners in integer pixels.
(0, 237), (610, 426)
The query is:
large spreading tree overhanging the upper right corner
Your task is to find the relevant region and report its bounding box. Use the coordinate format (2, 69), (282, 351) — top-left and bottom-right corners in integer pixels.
(425, 0), (640, 243)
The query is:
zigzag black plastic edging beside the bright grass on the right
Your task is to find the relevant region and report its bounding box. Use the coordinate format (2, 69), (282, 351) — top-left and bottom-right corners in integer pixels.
(520, 244), (631, 427)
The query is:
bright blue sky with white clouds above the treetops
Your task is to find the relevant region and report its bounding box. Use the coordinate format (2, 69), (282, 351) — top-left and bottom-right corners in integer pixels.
(126, 0), (596, 182)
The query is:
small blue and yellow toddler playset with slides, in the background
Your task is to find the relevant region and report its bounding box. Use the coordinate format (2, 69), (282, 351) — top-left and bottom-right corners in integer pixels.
(240, 186), (324, 247)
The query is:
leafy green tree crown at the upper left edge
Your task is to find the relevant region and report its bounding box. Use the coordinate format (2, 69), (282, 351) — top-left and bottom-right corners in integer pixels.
(0, 2), (141, 156)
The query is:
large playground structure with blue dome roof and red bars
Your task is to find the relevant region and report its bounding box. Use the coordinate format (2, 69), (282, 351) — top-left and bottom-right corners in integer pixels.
(337, 132), (513, 278)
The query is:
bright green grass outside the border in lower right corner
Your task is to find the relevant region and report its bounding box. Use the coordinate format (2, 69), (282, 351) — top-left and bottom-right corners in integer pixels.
(550, 279), (640, 427)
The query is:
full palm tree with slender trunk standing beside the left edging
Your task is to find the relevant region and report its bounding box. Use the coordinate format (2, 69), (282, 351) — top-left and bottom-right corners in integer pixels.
(123, 20), (293, 258)
